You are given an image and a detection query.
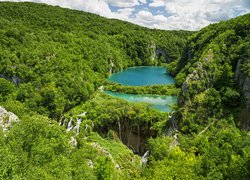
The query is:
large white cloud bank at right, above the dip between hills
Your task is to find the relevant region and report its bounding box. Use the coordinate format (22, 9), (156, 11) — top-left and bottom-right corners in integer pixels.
(133, 0), (250, 30)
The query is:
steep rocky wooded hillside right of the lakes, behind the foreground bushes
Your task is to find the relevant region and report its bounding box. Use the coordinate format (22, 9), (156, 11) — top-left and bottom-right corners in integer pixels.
(168, 14), (250, 132)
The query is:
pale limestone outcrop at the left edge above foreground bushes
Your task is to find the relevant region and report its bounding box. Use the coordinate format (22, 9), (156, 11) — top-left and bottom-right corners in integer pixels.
(0, 106), (19, 132)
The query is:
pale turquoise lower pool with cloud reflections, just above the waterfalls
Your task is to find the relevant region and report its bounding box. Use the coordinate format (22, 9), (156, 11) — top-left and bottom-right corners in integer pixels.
(105, 91), (177, 112)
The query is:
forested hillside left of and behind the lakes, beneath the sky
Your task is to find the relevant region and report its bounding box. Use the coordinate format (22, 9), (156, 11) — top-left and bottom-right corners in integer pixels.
(0, 2), (190, 118)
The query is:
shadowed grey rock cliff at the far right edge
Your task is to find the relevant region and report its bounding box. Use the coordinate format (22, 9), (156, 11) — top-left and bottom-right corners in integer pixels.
(235, 59), (250, 129)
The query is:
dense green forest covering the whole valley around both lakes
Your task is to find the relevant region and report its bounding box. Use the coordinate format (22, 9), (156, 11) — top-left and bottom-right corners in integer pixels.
(0, 2), (250, 179)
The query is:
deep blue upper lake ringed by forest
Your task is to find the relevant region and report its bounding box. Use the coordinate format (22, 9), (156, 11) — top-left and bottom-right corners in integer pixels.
(108, 66), (174, 86)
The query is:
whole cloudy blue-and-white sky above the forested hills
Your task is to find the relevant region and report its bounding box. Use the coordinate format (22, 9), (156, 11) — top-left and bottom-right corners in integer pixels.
(0, 0), (250, 30)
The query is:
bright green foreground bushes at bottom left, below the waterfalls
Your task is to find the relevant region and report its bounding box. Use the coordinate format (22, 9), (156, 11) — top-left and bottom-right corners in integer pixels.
(0, 115), (139, 179)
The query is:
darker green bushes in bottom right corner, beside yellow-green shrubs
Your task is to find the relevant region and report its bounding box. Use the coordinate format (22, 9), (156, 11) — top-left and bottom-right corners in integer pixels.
(180, 119), (250, 179)
